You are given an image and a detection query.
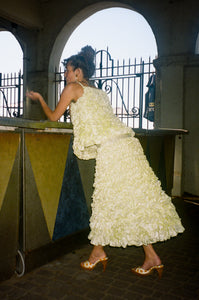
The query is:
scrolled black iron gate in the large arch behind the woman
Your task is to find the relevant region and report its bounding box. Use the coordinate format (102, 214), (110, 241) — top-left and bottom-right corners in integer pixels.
(55, 49), (155, 129)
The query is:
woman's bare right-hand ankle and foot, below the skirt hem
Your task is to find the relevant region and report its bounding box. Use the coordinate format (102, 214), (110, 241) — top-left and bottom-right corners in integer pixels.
(142, 245), (161, 270)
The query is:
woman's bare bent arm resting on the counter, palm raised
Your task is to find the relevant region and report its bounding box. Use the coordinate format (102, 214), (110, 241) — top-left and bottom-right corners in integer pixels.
(26, 84), (83, 121)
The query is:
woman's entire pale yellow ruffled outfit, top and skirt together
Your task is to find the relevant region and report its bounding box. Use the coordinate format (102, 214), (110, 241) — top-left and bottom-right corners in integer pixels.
(71, 82), (184, 248)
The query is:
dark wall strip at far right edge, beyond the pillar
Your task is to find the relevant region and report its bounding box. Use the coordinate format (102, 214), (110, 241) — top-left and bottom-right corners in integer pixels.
(183, 65), (199, 195)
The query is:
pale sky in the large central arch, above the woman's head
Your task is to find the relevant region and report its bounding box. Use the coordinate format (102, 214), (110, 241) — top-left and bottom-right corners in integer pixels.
(61, 8), (157, 64)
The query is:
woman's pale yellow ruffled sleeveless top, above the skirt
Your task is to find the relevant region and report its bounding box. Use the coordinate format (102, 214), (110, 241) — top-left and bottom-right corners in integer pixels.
(71, 87), (134, 159)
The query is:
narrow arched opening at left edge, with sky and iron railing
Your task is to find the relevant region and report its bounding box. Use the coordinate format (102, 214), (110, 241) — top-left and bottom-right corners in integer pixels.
(0, 29), (23, 117)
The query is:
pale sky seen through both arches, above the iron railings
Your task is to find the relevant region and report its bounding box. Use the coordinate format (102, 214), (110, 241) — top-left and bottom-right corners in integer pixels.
(0, 8), (157, 73)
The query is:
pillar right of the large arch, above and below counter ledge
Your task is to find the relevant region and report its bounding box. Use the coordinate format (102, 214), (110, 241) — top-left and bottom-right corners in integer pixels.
(154, 57), (184, 196)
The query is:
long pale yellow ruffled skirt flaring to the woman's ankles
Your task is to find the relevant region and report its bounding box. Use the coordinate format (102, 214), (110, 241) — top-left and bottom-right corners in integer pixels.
(89, 137), (184, 247)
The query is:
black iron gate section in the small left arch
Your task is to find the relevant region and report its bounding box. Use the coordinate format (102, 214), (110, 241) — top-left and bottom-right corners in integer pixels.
(0, 72), (23, 117)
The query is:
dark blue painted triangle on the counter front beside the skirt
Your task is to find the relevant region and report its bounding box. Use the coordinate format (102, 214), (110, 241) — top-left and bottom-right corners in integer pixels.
(53, 138), (89, 240)
